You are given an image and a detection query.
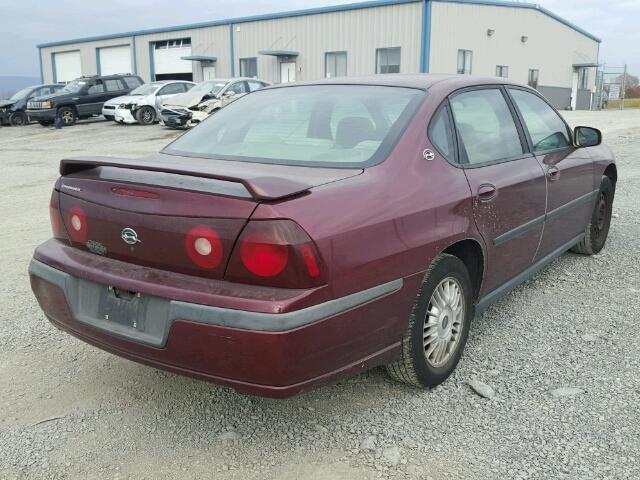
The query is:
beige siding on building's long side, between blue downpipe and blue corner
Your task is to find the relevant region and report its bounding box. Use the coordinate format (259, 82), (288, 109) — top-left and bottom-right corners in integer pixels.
(234, 3), (422, 82)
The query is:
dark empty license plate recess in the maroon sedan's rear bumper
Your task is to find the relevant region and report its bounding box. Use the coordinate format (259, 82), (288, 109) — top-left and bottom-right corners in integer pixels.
(98, 287), (146, 332)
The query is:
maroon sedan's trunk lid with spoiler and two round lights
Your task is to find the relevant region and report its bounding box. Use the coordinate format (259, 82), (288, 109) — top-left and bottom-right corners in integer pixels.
(56, 155), (361, 278)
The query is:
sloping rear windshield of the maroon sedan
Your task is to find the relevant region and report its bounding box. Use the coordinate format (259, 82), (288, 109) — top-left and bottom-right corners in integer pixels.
(163, 85), (424, 167)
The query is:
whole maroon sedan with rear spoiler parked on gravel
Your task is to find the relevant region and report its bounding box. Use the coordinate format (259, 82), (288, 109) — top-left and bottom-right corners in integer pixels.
(29, 75), (617, 397)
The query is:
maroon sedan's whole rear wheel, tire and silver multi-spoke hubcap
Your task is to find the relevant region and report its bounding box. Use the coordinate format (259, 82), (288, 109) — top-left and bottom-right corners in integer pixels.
(387, 254), (473, 387)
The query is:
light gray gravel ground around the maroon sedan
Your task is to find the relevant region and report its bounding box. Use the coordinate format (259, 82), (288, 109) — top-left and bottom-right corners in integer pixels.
(0, 110), (640, 480)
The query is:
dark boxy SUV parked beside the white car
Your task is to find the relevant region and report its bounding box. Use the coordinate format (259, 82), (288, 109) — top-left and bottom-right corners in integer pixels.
(27, 74), (144, 126)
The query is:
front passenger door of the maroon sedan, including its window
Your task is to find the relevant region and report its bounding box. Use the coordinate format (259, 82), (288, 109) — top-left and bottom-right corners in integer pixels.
(508, 87), (594, 258)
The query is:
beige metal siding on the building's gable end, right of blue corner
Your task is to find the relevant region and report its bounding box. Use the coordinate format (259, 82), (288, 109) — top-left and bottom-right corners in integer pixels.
(429, 2), (598, 88)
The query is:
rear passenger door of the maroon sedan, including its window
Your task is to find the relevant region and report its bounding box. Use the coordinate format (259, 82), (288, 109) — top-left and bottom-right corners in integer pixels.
(450, 87), (546, 294)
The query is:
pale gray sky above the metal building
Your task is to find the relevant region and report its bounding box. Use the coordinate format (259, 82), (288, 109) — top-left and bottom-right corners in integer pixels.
(0, 0), (640, 76)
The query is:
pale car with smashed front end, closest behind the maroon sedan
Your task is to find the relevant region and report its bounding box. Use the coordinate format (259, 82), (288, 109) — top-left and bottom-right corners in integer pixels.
(160, 77), (271, 128)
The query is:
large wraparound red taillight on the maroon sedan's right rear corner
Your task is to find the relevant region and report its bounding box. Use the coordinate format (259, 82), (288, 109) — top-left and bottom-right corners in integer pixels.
(225, 220), (324, 288)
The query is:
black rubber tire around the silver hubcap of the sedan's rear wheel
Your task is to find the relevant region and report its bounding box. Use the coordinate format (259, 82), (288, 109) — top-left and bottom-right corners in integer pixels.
(386, 254), (474, 388)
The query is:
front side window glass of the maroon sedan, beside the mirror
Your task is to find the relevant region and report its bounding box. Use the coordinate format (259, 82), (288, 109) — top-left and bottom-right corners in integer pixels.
(509, 88), (571, 152)
